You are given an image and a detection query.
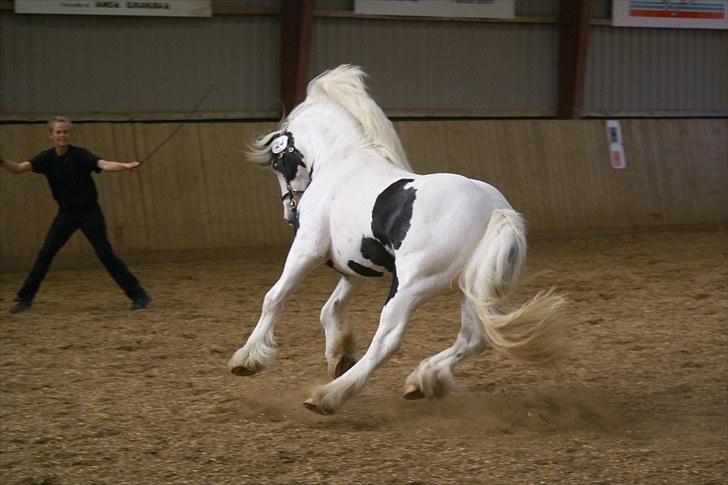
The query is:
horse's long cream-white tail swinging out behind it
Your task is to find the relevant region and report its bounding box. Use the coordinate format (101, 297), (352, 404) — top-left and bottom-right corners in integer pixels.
(460, 209), (566, 365)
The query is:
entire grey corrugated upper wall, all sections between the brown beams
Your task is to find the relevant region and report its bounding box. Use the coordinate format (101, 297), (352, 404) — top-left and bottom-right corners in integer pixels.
(0, 0), (728, 121)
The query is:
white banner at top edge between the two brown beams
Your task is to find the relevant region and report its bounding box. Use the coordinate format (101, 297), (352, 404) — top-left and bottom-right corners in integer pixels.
(354, 0), (515, 19)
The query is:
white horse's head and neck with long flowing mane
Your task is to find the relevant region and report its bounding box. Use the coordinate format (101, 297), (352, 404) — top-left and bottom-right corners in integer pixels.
(248, 65), (411, 228)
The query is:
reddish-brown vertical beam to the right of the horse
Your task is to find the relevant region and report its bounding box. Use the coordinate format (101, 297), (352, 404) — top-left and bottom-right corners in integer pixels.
(557, 0), (591, 119)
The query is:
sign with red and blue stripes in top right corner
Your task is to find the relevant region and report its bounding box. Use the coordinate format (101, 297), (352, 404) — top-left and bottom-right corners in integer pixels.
(612, 0), (728, 29)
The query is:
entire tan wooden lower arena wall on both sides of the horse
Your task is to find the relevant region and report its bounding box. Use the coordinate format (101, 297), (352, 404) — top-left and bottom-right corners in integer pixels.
(0, 119), (728, 267)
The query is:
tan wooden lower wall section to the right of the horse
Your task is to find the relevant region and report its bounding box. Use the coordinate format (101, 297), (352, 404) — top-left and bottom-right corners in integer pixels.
(395, 119), (728, 233)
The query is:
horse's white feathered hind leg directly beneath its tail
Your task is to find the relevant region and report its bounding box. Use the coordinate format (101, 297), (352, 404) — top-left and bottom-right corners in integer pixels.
(404, 296), (487, 399)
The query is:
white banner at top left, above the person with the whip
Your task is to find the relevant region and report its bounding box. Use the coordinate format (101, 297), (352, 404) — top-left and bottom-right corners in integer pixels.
(15, 0), (212, 17)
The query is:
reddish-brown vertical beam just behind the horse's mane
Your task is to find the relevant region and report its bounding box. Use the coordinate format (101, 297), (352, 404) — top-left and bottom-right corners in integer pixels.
(280, 0), (313, 113)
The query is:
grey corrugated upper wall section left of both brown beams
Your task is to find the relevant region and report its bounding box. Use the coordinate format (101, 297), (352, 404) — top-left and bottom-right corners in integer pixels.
(0, 11), (279, 119)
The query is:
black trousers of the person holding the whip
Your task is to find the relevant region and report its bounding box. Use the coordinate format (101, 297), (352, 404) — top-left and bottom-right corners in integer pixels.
(18, 203), (144, 301)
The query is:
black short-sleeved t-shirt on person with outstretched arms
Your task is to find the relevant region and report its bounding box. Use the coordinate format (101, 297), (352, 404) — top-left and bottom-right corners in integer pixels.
(30, 145), (101, 210)
